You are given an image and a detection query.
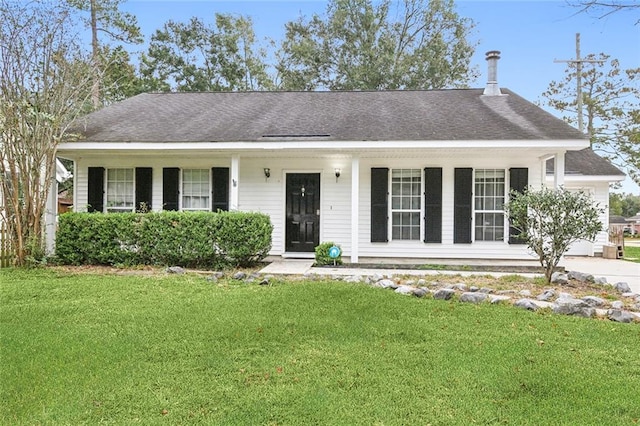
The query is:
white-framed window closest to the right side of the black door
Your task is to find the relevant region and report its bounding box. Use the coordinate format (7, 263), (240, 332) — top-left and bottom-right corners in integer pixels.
(389, 168), (424, 241)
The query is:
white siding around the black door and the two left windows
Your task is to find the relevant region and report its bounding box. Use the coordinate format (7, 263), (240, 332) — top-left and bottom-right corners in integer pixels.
(74, 157), (351, 256)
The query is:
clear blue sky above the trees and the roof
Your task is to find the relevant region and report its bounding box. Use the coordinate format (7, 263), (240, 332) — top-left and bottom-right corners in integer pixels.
(116, 0), (640, 195)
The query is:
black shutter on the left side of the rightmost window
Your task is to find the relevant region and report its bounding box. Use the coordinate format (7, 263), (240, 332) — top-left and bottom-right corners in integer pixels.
(453, 168), (473, 244)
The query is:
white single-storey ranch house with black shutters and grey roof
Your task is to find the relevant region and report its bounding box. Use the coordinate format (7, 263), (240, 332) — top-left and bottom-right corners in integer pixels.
(52, 52), (624, 263)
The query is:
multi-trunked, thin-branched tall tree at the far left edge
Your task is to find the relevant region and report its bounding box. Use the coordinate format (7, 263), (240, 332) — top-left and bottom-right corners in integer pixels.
(0, 0), (92, 265)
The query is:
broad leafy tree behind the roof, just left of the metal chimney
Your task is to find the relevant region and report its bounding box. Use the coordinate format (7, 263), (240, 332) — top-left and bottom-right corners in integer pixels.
(277, 0), (477, 90)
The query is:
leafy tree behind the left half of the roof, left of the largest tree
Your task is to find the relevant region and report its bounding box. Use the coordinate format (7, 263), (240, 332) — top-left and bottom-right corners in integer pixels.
(140, 13), (273, 91)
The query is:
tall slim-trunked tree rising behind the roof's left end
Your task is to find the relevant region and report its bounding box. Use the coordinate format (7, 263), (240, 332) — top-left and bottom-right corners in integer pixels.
(67, 0), (143, 110)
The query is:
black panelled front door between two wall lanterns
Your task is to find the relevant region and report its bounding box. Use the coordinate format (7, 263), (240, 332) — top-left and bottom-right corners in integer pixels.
(285, 173), (320, 253)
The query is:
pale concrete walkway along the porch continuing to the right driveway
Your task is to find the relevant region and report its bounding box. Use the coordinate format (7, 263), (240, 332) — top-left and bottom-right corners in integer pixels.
(260, 256), (640, 294)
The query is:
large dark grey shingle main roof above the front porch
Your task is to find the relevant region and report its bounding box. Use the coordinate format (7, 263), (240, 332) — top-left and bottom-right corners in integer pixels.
(72, 89), (584, 142)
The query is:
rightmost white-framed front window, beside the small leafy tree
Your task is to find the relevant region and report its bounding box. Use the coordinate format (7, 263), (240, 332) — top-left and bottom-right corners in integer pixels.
(472, 168), (509, 243)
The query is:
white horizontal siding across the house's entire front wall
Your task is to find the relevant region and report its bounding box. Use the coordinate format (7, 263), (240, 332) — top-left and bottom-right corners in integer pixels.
(74, 150), (608, 259)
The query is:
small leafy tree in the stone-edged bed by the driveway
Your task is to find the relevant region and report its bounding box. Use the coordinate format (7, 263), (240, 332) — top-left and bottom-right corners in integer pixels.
(506, 188), (604, 283)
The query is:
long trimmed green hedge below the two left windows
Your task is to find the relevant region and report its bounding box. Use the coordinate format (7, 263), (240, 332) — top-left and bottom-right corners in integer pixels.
(56, 212), (273, 268)
